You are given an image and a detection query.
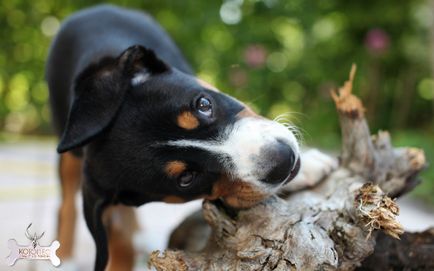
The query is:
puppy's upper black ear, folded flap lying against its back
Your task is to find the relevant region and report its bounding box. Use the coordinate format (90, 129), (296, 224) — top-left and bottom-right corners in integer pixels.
(57, 45), (170, 153)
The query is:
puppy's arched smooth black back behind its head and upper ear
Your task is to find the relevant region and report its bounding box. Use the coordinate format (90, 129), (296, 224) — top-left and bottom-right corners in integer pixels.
(46, 5), (192, 136)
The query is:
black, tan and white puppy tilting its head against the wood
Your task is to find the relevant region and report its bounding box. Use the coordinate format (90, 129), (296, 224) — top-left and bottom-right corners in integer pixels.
(47, 6), (300, 270)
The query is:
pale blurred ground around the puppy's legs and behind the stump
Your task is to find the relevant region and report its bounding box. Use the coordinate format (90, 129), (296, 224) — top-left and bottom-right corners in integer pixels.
(0, 141), (434, 271)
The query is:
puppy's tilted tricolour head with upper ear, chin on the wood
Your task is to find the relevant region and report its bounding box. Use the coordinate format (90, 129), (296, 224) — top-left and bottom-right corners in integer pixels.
(58, 46), (300, 207)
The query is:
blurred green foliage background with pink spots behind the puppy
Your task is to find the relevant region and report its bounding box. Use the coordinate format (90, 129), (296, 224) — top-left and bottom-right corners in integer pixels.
(0, 0), (434, 204)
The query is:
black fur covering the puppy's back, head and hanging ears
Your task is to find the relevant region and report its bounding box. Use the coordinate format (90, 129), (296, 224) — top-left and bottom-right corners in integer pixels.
(47, 6), (244, 270)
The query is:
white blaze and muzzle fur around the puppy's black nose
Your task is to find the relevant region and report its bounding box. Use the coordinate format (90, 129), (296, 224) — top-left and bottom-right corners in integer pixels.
(166, 117), (299, 188)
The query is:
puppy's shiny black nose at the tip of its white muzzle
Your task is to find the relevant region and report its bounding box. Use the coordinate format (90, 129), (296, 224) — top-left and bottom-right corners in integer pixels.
(262, 140), (296, 184)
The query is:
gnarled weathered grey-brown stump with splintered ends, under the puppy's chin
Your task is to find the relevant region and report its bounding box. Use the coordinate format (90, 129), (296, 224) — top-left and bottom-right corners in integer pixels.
(150, 67), (425, 270)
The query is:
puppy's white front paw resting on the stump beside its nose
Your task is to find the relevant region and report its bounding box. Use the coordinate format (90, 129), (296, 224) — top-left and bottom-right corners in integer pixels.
(282, 149), (339, 192)
